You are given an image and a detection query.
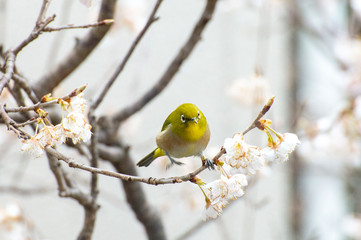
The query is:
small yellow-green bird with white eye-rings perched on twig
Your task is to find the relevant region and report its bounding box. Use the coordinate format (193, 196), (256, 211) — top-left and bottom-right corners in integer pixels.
(137, 103), (214, 169)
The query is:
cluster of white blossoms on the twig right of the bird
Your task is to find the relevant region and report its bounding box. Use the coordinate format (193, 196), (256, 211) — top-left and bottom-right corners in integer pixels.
(202, 121), (300, 219)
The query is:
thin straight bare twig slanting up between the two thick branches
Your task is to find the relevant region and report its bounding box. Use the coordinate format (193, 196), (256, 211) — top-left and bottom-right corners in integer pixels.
(90, 0), (163, 110)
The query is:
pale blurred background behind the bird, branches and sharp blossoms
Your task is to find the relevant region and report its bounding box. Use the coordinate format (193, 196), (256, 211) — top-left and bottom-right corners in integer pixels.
(0, 0), (361, 240)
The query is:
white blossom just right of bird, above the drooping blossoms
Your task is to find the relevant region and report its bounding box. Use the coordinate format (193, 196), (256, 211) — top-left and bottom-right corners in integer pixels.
(223, 133), (264, 174)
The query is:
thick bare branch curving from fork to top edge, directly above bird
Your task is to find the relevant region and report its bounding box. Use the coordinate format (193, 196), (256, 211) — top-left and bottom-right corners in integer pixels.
(112, 0), (217, 123)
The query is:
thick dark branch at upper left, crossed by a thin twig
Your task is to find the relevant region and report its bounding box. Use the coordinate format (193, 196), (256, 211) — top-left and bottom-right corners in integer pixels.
(33, 0), (116, 96)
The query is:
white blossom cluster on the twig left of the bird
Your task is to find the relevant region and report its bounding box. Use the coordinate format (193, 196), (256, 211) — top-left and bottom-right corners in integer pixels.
(21, 93), (91, 158)
